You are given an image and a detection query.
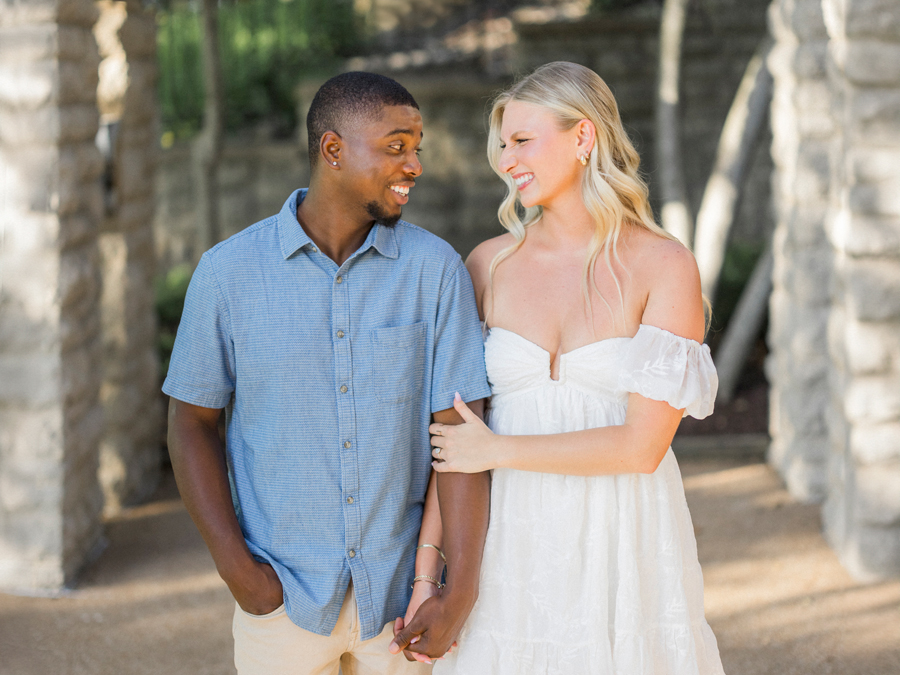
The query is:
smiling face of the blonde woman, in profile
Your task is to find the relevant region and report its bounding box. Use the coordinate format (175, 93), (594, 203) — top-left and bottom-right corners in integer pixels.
(498, 101), (582, 208)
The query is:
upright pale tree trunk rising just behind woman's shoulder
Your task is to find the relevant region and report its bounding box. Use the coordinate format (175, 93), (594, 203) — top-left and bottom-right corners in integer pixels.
(656, 0), (694, 248)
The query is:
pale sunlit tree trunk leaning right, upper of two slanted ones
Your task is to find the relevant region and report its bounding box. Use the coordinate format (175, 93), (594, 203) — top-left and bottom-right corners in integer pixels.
(694, 36), (772, 302)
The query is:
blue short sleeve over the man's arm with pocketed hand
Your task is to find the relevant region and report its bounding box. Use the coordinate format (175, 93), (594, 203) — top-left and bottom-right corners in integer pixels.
(162, 252), (235, 408)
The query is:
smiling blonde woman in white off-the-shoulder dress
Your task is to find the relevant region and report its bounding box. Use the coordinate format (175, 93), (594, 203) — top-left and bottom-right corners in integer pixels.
(431, 62), (722, 675)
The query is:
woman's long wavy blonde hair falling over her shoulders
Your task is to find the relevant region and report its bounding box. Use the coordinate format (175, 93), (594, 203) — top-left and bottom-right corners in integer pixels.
(488, 61), (678, 327)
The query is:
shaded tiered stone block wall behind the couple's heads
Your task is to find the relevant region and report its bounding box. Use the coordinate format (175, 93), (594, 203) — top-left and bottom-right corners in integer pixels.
(155, 0), (772, 268)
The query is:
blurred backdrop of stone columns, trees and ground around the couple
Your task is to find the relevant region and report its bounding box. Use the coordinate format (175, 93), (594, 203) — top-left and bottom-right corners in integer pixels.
(0, 0), (900, 675)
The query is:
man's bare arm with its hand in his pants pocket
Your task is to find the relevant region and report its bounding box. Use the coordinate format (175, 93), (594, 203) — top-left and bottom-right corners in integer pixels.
(168, 398), (283, 614)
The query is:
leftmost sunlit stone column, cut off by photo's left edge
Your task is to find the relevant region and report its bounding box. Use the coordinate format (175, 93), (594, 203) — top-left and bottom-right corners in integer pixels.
(0, 0), (103, 590)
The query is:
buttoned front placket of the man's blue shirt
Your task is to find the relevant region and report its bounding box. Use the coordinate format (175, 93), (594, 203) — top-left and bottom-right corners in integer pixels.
(331, 265), (362, 578)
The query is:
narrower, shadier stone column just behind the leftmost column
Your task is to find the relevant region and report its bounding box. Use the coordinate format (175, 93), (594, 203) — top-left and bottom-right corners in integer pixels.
(94, 0), (163, 514)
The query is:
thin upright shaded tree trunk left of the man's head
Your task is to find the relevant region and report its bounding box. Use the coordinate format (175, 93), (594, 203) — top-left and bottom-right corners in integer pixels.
(193, 0), (224, 258)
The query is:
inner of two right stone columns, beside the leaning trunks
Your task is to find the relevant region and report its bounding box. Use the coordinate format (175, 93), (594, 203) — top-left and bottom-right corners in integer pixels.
(766, 0), (834, 502)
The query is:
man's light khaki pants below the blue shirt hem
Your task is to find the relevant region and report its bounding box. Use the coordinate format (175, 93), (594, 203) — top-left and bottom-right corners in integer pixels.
(232, 584), (431, 675)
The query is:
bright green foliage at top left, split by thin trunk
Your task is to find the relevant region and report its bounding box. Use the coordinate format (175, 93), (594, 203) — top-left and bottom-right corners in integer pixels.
(157, 0), (360, 139)
